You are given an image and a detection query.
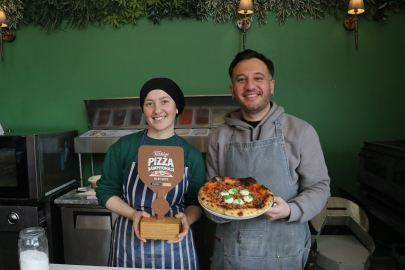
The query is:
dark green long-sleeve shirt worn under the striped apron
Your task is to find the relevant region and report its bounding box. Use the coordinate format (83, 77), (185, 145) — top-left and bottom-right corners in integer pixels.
(95, 132), (205, 207)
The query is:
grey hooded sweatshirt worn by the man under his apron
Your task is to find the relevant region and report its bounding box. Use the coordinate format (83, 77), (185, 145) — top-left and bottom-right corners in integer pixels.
(206, 101), (330, 223)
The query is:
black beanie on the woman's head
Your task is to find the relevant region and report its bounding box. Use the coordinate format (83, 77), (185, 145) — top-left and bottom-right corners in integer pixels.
(139, 78), (185, 115)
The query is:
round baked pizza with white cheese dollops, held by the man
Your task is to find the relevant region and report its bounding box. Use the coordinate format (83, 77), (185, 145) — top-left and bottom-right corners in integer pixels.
(198, 176), (274, 218)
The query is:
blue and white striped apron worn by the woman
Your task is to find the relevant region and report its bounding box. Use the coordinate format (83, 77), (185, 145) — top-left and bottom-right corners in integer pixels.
(108, 131), (199, 269)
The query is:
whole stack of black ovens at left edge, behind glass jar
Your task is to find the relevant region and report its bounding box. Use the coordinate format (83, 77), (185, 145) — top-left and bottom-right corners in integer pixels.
(0, 131), (78, 270)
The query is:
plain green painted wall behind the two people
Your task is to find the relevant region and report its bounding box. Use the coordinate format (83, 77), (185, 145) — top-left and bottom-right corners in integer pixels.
(0, 13), (405, 195)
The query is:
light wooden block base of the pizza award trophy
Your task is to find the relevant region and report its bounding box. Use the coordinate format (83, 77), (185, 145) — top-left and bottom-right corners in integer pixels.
(140, 216), (181, 240)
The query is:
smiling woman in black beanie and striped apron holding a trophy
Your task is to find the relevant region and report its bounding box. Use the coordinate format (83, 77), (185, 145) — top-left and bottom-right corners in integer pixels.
(96, 78), (205, 269)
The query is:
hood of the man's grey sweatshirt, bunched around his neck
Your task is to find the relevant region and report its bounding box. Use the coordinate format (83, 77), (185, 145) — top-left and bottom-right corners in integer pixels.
(224, 101), (284, 131)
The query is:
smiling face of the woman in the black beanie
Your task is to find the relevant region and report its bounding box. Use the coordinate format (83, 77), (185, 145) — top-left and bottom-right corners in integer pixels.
(143, 90), (178, 139)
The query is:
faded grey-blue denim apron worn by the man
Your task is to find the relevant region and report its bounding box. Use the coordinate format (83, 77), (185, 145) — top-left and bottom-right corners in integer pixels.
(212, 117), (311, 270)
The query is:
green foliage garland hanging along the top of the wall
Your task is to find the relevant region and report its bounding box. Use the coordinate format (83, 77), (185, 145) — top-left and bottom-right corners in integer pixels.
(0, 0), (405, 32)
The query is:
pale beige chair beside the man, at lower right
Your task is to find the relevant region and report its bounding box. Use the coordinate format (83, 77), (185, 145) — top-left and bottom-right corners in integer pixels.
(305, 197), (375, 270)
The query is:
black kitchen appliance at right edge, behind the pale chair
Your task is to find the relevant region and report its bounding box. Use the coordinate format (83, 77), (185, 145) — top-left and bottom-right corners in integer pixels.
(339, 140), (405, 269)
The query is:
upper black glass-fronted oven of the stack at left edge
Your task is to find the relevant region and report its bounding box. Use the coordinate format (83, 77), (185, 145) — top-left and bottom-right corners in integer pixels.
(0, 131), (78, 199)
